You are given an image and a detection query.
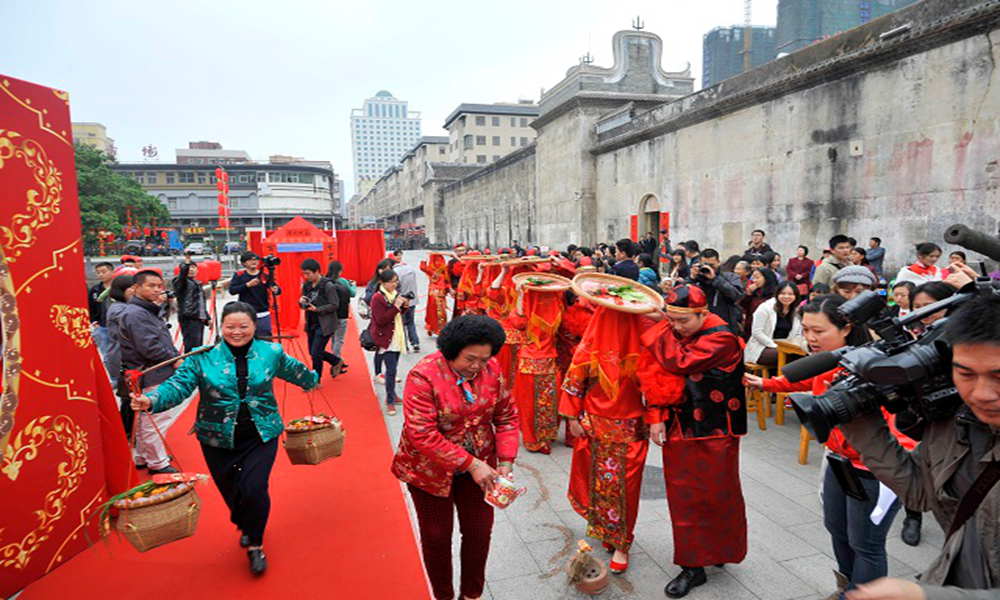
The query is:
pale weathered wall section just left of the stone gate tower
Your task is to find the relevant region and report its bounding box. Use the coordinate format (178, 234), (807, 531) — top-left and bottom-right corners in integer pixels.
(432, 144), (540, 248)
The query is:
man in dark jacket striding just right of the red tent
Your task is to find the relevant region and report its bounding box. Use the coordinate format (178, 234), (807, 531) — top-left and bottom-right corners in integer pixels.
(299, 258), (343, 379)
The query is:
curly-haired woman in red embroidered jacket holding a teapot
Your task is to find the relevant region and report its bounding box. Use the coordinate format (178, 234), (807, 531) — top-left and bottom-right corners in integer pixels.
(392, 315), (518, 600)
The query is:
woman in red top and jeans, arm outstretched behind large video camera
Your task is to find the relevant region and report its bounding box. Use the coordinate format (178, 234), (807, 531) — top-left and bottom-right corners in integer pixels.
(743, 295), (916, 598)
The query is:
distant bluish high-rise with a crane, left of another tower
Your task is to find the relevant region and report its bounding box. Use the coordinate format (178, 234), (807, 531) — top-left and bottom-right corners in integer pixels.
(701, 25), (775, 88)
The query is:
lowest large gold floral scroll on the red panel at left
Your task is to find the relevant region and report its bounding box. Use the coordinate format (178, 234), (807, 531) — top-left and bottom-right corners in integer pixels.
(0, 415), (88, 569)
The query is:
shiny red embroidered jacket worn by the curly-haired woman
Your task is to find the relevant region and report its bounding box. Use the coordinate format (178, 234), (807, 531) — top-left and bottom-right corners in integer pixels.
(392, 352), (518, 497)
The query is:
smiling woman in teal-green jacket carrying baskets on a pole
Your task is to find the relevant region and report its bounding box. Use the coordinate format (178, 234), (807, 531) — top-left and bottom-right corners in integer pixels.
(132, 302), (318, 575)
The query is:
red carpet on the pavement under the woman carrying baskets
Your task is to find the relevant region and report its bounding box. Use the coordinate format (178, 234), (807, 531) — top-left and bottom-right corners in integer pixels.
(20, 321), (430, 600)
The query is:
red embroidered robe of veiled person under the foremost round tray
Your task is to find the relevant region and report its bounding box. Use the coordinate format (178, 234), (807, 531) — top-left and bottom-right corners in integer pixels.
(559, 307), (649, 552)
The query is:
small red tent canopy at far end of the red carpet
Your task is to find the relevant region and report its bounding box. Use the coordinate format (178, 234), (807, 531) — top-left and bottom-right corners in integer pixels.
(261, 217), (337, 333)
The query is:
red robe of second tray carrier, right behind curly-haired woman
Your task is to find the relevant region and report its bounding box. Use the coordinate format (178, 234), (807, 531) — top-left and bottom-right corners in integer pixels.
(514, 289), (564, 453)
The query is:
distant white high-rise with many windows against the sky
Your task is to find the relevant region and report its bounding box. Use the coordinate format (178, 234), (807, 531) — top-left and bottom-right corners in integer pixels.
(351, 90), (420, 190)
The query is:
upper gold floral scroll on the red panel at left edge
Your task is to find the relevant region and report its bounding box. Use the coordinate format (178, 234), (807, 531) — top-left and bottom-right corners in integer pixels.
(0, 129), (63, 263)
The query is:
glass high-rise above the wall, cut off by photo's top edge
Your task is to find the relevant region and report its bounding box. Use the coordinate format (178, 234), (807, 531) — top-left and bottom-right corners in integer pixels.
(776, 0), (917, 54)
